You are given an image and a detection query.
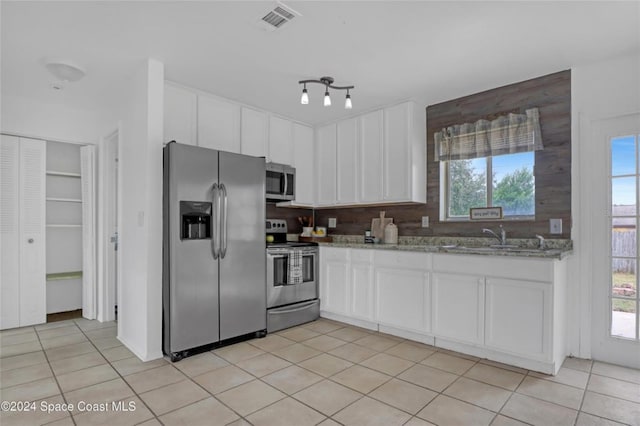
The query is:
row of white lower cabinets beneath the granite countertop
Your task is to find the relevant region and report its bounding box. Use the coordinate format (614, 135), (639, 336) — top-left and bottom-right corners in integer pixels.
(320, 246), (566, 374)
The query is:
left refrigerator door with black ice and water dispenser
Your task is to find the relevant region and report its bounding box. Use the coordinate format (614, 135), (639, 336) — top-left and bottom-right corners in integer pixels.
(163, 143), (220, 354)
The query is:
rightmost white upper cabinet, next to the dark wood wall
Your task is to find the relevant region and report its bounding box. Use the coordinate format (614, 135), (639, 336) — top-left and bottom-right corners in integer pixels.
(383, 102), (427, 203)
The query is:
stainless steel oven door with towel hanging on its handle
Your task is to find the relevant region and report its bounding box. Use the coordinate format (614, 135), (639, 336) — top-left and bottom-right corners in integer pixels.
(267, 247), (318, 308)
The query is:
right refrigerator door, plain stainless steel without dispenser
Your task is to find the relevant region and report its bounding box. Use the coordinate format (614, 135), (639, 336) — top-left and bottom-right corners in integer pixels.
(219, 152), (267, 340)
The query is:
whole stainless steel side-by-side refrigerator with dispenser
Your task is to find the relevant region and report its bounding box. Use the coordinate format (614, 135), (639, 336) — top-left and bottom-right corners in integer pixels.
(163, 142), (266, 361)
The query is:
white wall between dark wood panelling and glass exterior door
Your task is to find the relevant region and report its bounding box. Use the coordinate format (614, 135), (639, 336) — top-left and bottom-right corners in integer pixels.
(568, 54), (640, 358)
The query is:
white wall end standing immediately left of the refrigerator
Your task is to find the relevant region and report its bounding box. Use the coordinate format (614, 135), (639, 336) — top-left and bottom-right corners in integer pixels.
(118, 59), (164, 361)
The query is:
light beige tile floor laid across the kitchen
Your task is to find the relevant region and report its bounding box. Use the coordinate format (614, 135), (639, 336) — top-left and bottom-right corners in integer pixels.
(0, 319), (640, 426)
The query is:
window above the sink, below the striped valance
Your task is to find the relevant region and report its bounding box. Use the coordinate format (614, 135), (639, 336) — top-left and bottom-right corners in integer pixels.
(441, 151), (535, 220)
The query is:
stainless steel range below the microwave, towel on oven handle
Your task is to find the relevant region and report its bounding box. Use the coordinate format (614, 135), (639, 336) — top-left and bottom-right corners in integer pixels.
(266, 219), (320, 333)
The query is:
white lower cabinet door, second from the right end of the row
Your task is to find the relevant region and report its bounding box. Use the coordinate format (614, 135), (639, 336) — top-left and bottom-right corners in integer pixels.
(431, 272), (484, 343)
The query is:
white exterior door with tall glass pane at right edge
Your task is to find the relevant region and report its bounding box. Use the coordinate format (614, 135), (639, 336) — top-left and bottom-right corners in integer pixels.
(591, 114), (640, 368)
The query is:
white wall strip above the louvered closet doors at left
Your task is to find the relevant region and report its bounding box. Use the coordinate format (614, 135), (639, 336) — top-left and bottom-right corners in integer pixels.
(0, 94), (104, 145)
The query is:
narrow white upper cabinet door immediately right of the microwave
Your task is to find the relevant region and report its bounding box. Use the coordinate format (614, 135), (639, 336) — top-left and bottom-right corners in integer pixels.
(293, 123), (315, 206)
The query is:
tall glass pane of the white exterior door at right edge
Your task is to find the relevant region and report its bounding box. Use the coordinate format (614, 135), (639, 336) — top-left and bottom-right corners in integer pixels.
(609, 135), (640, 340)
